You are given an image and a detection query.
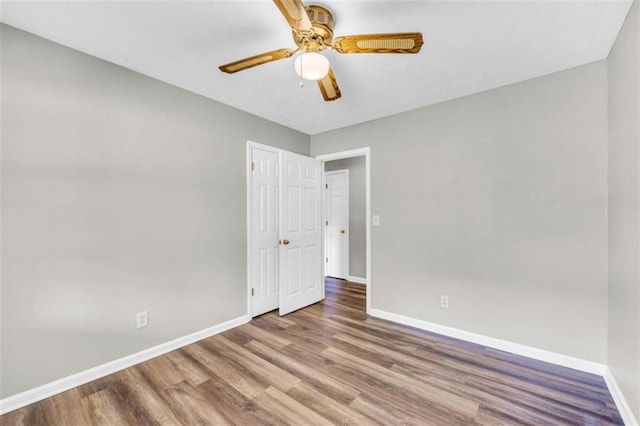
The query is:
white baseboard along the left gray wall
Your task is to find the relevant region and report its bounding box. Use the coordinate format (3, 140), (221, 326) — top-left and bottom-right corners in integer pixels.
(0, 315), (251, 415)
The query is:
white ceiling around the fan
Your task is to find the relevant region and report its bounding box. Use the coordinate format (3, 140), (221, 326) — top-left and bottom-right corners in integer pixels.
(0, 0), (631, 134)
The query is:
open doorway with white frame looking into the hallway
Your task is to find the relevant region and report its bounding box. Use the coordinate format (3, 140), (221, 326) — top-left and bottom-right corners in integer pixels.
(316, 148), (372, 312)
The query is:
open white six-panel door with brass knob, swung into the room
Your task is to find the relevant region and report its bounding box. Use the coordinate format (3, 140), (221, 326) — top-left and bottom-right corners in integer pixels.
(279, 151), (324, 315)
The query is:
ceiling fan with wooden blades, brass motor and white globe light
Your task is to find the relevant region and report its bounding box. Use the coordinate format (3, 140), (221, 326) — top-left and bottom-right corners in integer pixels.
(219, 0), (423, 101)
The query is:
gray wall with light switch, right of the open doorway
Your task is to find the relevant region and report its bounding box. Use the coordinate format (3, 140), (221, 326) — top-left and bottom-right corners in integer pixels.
(311, 61), (607, 363)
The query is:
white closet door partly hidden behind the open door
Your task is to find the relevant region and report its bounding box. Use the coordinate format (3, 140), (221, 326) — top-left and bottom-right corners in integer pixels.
(249, 146), (279, 317)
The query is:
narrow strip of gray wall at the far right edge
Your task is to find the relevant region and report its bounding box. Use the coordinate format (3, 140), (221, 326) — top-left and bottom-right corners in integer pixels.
(608, 2), (640, 420)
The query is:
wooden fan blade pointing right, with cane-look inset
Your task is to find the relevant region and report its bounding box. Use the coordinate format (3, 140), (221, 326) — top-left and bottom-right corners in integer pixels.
(333, 33), (424, 53)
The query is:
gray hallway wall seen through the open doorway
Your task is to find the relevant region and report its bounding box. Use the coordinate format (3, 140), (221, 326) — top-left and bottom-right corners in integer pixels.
(324, 157), (367, 278)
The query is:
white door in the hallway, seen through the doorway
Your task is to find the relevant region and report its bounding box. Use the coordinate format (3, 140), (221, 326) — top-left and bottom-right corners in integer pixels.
(325, 170), (349, 279)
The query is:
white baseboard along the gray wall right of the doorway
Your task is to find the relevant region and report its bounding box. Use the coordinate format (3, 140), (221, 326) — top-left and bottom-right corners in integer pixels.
(369, 309), (607, 376)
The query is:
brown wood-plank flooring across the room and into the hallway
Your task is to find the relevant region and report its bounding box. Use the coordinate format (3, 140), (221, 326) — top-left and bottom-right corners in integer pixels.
(0, 279), (622, 426)
